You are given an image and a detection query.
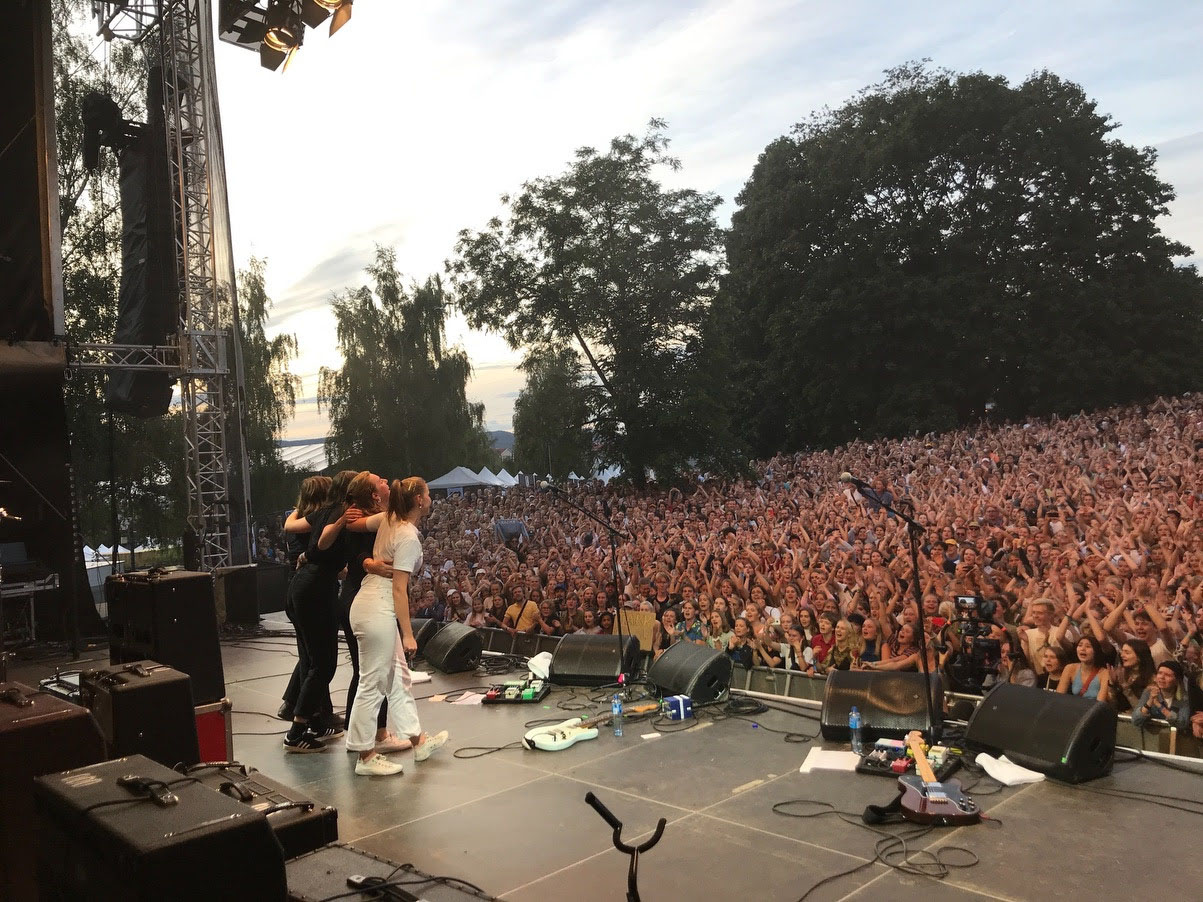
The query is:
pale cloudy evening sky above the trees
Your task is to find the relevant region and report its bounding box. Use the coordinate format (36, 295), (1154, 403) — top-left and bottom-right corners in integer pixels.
(218, 0), (1203, 438)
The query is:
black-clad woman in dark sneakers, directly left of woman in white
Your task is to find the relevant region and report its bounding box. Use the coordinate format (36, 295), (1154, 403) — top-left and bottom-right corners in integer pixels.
(284, 470), (358, 752)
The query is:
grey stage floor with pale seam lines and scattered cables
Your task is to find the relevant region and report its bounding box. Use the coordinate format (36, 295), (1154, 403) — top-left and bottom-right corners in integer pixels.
(10, 639), (1203, 902)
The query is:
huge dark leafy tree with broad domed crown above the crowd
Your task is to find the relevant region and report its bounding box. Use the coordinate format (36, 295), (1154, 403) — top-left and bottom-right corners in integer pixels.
(717, 65), (1203, 453)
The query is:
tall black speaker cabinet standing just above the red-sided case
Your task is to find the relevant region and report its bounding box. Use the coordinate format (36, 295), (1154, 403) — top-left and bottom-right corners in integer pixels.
(105, 570), (225, 705)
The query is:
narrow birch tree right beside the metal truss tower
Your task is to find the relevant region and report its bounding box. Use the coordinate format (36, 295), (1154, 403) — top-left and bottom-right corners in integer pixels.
(238, 257), (300, 514)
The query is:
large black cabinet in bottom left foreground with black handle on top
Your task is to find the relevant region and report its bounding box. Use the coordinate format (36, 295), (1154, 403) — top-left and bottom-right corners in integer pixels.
(34, 755), (288, 902)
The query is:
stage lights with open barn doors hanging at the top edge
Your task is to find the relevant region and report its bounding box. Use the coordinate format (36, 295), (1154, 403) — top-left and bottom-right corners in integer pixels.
(218, 0), (352, 71)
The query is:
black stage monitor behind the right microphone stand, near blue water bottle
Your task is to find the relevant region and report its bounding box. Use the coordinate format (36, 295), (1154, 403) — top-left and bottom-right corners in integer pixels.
(819, 670), (944, 742)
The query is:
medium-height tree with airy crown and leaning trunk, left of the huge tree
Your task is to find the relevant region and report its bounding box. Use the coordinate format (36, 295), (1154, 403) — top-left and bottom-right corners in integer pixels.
(449, 120), (734, 483)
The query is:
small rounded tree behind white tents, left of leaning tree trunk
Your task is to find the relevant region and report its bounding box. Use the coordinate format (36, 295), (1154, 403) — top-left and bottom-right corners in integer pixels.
(514, 345), (593, 479)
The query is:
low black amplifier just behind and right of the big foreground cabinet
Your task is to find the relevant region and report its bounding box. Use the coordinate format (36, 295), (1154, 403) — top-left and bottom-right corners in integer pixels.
(184, 761), (338, 859)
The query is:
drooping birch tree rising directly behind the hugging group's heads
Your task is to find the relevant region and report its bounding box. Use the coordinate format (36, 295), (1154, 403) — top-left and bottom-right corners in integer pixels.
(318, 248), (499, 477)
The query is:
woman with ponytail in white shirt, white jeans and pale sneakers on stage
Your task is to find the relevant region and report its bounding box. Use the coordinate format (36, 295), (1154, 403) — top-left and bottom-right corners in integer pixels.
(346, 476), (448, 777)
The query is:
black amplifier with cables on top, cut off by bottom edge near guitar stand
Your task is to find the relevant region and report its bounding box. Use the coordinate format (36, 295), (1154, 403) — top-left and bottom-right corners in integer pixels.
(288, 843), (496, 902)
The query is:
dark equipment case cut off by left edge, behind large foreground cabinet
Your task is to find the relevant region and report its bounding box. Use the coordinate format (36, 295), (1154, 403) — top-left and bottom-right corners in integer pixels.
(0, 683), (105, 902)
